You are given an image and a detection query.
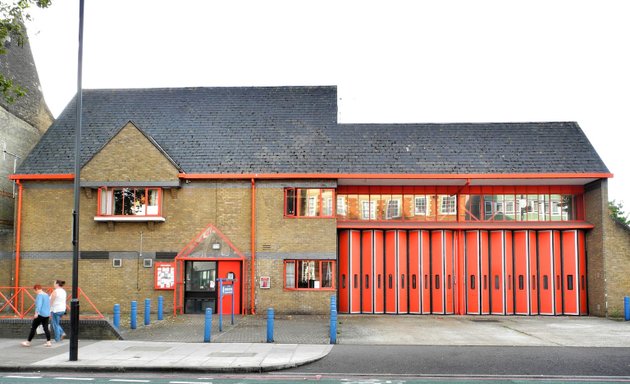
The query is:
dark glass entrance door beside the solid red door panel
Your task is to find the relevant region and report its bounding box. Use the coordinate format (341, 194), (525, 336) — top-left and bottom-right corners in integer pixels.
(184, 261), (217, 313)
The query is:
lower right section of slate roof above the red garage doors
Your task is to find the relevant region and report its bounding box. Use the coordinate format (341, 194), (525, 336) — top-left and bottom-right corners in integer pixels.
(339, 122), (608, 174)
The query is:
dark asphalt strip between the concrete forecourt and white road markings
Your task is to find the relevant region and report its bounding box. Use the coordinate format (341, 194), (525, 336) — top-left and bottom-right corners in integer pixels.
(283, 345), (630, 378)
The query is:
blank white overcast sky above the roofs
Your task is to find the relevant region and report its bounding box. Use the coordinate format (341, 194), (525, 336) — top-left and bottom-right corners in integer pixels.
(22, 0), (630, 207)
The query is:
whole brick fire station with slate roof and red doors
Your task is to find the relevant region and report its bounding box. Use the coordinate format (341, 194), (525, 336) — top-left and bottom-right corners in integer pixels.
(8, 87), (630, 316)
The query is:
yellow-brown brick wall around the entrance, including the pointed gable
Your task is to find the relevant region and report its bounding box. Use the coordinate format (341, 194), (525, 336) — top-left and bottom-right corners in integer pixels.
(12, 123), (336, 313)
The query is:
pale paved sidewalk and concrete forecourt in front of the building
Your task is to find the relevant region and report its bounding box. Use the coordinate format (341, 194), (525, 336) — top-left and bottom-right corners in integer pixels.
(0, 315), (630, 372)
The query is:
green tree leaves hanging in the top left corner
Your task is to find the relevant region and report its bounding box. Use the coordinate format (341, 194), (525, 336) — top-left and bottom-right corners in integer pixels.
(0, 0), (52, 103)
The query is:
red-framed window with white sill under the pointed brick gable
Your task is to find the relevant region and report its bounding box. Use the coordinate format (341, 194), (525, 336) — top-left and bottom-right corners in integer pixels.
(98, 187), (162, 216)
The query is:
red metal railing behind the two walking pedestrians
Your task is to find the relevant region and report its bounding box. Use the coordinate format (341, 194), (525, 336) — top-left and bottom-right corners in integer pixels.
(0, 287), (105, 320)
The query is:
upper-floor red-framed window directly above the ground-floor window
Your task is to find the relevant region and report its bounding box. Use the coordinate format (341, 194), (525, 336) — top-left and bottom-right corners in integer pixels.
(284, 188), (335, 217)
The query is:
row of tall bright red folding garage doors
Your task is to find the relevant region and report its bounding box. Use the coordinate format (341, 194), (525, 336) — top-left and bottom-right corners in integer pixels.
(338, 230), (588, 315)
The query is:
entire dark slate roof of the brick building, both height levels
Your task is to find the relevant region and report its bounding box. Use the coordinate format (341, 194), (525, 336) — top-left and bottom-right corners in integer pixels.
(16, 86), (609, 174)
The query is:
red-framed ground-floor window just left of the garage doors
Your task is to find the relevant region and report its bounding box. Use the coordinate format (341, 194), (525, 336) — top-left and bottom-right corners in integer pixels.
(284, 260), (335, 289)
